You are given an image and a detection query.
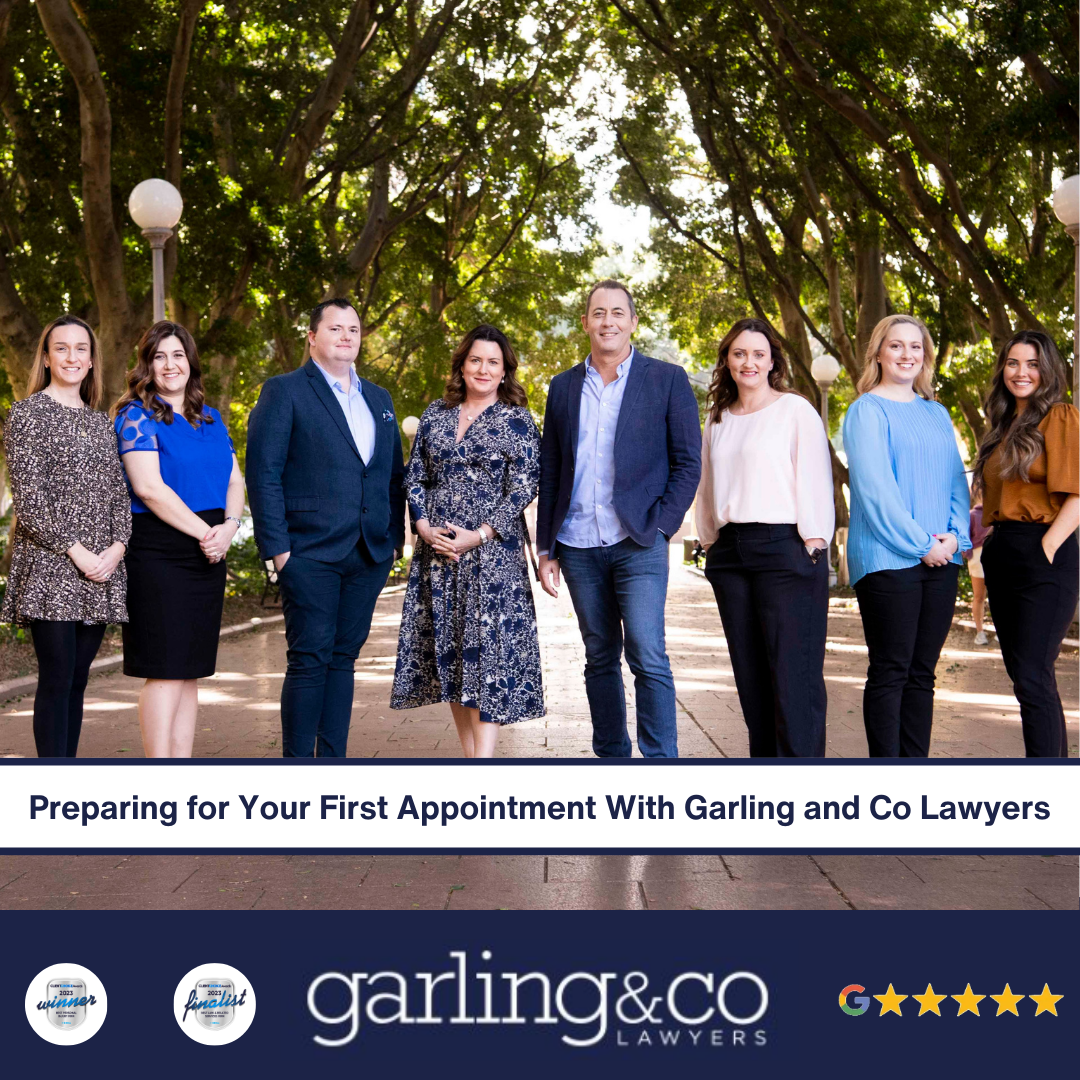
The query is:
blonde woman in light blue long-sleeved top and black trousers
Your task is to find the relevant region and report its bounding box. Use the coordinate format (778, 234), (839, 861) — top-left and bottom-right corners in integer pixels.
(843, 315), (971, 757)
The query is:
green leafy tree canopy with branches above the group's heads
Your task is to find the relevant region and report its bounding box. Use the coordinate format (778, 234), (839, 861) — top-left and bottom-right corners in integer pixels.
(0, 0), (1078, 462)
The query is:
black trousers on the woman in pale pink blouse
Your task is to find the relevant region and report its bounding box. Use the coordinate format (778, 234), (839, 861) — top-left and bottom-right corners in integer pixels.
(705, 523), (828, 757)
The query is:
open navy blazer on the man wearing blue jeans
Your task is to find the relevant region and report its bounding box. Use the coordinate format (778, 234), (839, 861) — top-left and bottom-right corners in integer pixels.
(537, 350), (701, 553)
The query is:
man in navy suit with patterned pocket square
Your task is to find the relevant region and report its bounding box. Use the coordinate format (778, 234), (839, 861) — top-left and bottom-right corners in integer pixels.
(247, 299), (405, 757)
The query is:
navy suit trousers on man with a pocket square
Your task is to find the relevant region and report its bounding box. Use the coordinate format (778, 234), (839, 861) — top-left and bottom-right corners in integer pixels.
(278, 549), (393, 757)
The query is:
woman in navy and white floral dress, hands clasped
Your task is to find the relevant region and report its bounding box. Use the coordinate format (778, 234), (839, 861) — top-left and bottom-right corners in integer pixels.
(390, 325), (544, 757)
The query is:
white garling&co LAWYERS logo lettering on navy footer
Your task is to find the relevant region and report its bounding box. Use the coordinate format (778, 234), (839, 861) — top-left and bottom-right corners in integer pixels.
(307, 949), (769, 1048)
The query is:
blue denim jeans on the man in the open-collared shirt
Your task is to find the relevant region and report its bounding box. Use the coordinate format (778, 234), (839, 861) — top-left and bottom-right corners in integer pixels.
(556, 532), (678, 757)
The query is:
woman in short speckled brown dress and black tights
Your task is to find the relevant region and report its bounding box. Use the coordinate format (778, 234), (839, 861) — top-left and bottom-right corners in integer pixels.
(0, 315), (132, 757)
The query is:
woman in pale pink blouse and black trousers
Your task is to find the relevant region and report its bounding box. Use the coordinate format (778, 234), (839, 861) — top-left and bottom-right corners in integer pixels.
(697, 319), (835, 757)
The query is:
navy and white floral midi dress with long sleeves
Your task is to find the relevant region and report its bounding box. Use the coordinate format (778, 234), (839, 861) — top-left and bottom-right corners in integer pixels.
(390, 401), (544, 724)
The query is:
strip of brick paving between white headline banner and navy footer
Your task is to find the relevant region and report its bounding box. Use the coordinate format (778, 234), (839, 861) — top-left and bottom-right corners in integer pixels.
(0, 855), (1077, 912)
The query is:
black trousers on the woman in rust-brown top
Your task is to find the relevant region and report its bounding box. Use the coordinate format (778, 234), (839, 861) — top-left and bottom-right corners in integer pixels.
(983, 522), (1080, 757)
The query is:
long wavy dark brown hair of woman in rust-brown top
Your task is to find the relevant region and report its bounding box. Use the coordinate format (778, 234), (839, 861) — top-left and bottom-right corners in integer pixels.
(974, 330), (1068, 486)
